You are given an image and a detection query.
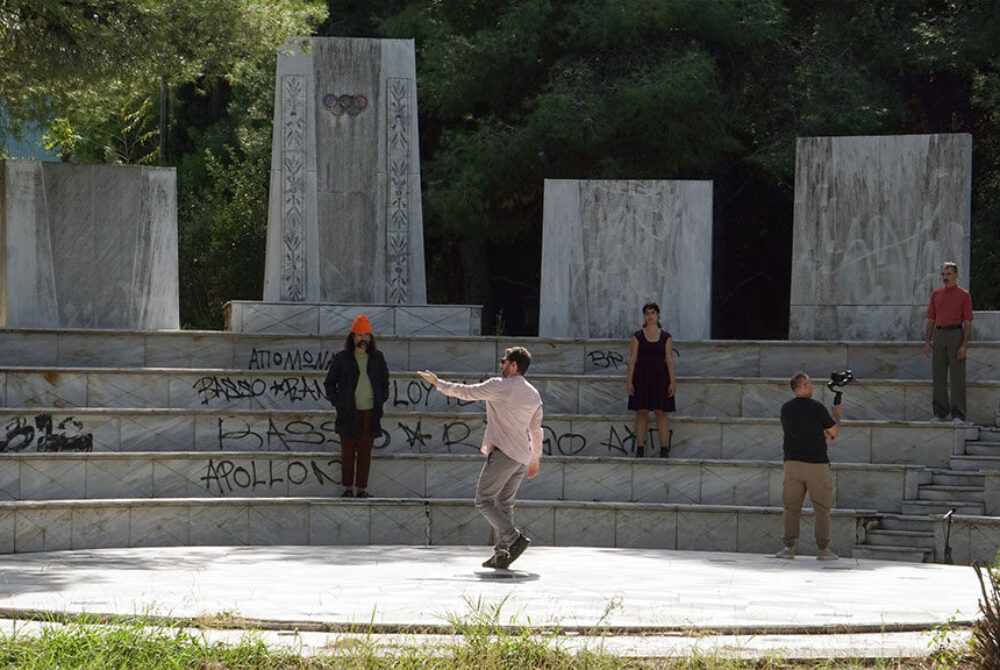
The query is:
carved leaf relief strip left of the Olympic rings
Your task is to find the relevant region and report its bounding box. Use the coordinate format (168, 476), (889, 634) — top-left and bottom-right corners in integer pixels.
(281, 75), (306, 302)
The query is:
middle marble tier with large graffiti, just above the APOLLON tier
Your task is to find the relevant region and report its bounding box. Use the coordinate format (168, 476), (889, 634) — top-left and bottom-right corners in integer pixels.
(0, 404), (974, 470)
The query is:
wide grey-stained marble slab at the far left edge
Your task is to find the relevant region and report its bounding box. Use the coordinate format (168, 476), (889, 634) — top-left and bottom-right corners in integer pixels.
(0, 161), (180, 330)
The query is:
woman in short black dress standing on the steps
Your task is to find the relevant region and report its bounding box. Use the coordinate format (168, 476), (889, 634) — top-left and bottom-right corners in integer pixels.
(627, 302), (677, 458)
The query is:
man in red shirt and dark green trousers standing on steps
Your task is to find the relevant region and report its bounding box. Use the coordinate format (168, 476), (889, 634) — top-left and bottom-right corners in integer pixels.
(924, 261), (972, 423)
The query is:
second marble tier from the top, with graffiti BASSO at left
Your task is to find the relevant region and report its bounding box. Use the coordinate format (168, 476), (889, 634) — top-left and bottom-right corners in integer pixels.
(0, 367), (1000, 426)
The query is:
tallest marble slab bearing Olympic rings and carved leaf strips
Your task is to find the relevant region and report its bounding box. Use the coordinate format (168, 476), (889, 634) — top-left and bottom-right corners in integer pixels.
(264, 37), (427, 305)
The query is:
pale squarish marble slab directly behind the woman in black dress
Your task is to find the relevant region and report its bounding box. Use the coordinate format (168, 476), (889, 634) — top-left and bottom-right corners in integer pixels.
(538, 179), (712, 340)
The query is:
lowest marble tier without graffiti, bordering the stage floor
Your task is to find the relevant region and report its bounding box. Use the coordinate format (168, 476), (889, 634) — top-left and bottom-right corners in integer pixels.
(0, 498), (859, 558)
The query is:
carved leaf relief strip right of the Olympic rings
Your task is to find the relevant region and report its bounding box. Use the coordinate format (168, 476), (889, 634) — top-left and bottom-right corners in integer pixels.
(386, 78), (412, 304)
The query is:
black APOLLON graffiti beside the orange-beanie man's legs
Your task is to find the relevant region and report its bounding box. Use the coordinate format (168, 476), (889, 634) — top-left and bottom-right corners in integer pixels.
(200, 458), (340, 495)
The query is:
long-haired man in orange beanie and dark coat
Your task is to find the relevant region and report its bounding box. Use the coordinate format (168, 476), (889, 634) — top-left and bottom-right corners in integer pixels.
(323, 314), (389, 498)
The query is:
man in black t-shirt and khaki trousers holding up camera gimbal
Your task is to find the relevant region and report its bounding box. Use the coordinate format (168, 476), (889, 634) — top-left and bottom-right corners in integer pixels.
(775, 370), (854, 561)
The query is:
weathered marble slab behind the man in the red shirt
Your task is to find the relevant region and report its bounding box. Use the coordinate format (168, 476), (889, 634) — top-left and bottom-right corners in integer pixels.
(789, 134), (972, 341)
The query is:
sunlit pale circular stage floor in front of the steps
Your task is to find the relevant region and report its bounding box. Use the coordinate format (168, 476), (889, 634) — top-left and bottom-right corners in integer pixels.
(0, 546), (980, 658)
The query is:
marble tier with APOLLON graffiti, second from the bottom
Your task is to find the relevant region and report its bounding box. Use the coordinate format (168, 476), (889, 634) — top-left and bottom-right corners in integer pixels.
(0, 452), (922, 512)
